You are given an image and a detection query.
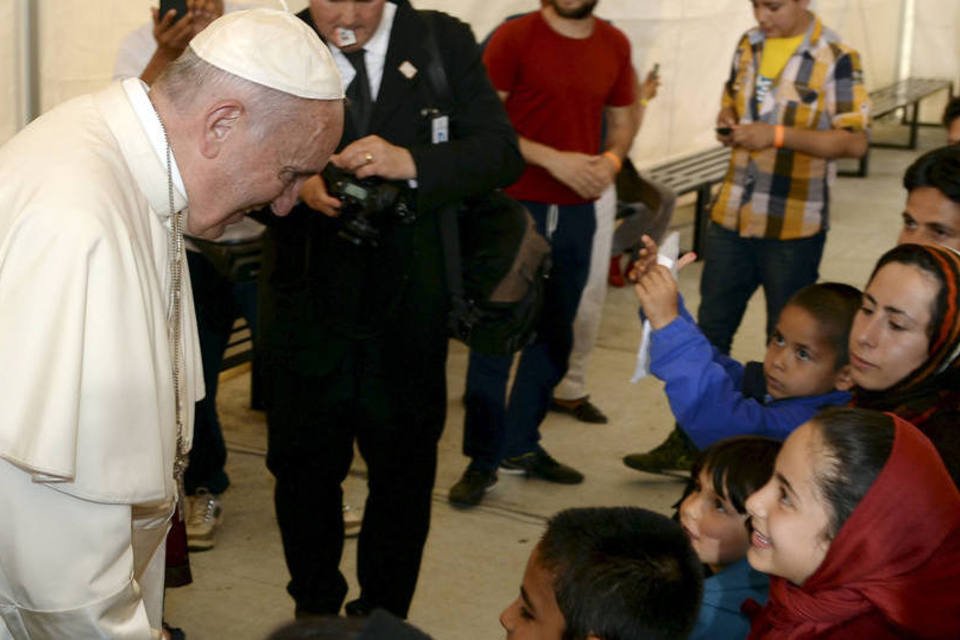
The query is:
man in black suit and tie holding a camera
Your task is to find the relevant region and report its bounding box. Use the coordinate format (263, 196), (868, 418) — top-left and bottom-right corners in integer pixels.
(261, 0), (523, 617)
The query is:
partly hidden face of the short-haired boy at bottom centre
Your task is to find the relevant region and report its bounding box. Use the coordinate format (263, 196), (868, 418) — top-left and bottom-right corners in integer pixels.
(500, 547), (567, 640)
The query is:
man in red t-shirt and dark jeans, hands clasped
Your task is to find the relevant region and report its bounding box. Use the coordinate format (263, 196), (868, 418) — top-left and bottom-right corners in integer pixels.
(450, 0), (637, 506)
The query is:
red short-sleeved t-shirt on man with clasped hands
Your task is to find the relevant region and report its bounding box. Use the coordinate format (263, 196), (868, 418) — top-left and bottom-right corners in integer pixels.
(483, 11), (636, 204)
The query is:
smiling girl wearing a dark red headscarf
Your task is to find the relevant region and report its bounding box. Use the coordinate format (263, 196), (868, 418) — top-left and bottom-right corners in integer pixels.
(747, 408), (960, 640)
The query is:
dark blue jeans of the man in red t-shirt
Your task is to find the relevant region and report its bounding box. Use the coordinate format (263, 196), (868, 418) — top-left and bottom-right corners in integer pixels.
(463, 202), (597, 471)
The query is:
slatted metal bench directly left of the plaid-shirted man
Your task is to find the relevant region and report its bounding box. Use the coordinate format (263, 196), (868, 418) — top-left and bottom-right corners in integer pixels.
(642, 147), (730, 256)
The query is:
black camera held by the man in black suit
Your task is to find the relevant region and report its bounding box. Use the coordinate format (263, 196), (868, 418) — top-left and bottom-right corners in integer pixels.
(321, 164), (414, 247)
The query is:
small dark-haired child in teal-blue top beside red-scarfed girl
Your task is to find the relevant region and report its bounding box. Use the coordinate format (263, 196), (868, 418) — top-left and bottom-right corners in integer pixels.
(677, 436), (780, 640)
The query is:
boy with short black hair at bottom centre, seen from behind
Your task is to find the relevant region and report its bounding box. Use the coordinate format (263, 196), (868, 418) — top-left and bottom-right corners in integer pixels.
(500, 507), (703, 640)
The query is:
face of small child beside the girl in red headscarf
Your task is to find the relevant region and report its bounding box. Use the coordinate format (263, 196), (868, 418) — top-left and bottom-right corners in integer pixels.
(680, 469), (750, 571)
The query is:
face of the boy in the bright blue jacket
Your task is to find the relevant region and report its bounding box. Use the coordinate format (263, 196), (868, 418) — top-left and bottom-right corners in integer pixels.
(763, 304), (839, 400)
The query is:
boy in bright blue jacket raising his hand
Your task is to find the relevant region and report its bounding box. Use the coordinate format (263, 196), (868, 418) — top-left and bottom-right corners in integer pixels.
(624, 246), (861, 450)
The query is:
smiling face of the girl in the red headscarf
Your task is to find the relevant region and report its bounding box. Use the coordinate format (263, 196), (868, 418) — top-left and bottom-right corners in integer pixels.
(747, 422), (830, 585)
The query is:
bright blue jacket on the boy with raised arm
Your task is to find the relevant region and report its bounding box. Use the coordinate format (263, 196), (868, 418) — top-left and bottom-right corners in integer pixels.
(650, 314), (850, 449)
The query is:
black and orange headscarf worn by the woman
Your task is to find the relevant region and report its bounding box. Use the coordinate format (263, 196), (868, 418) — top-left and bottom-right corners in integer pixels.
(853, 244), (960, 429)
